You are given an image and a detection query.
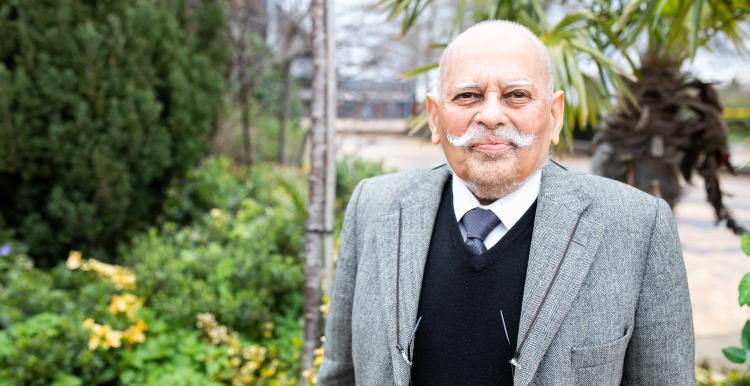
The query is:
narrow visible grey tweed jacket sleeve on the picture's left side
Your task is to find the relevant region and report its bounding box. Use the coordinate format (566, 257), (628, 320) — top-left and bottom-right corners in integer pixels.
(318, 180), (365, 386)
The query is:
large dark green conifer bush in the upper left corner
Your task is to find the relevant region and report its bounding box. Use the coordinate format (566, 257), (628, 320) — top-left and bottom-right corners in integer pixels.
(0, 0), (227, 265)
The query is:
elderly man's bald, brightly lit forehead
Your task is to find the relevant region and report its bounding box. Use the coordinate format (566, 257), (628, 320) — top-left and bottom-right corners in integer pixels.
(440, 34), (545, 88)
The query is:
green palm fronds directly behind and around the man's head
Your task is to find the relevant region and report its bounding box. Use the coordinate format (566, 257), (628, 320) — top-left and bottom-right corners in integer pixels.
(376, 0), (635, 144)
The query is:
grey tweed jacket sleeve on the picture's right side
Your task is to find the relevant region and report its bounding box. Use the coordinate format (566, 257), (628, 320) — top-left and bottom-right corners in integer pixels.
(622, 199), (695, 385)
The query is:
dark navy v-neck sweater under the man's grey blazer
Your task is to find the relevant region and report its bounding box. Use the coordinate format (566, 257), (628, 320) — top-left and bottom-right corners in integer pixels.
(411, 179), (536, 386)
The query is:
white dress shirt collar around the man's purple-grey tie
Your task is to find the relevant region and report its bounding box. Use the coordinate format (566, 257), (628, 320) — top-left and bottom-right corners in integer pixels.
(451, 168), (542, 249)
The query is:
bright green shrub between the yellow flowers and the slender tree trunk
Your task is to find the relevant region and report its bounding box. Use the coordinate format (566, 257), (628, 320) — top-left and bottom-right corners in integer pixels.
(123, 160), (305, 339)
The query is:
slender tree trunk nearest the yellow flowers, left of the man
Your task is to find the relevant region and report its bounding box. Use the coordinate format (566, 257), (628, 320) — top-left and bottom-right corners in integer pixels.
(300, 0), (326, 376)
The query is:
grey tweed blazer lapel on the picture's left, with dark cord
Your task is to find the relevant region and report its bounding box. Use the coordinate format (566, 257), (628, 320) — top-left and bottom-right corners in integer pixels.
(376, 166), (450, 385)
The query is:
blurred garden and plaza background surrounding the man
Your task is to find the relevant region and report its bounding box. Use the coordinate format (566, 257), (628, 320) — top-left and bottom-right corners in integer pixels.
(0, 0), (750, 385)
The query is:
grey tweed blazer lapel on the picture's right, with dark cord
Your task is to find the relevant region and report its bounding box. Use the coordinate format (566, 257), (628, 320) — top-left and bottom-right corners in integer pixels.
(514, 162), (603, 386)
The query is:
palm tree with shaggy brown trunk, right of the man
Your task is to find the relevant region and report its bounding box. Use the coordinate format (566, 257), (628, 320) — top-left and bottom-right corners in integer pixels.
(594, 0), (750, 234)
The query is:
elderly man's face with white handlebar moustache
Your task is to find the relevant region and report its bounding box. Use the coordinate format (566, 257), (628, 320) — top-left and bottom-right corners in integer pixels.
(427, 32), (563, 201)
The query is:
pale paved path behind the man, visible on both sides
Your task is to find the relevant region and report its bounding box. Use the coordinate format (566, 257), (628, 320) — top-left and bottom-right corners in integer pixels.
(338, 135), (750, 367)
